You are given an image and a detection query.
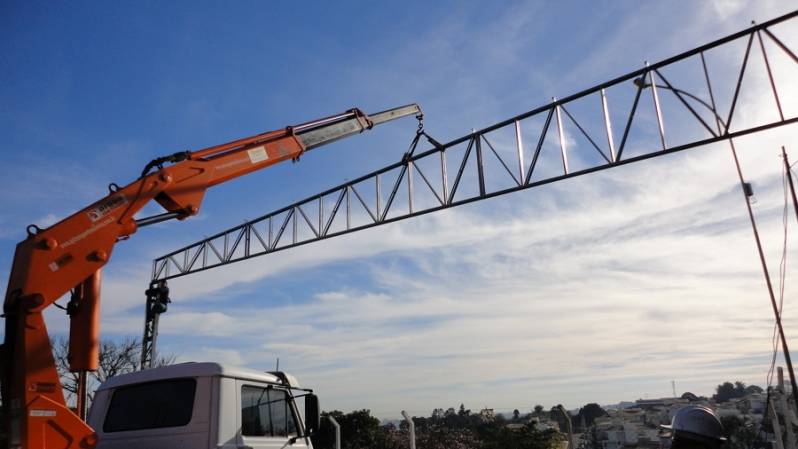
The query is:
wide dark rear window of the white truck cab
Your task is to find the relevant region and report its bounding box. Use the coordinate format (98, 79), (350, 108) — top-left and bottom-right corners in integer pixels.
(103, 378), (197, 432)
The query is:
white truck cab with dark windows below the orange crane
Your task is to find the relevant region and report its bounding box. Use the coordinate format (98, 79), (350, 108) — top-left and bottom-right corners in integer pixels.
(88, 362), (319, 449)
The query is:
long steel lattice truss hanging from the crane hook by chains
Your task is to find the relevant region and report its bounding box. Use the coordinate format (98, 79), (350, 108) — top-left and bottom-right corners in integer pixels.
(152, 11), (798, 280)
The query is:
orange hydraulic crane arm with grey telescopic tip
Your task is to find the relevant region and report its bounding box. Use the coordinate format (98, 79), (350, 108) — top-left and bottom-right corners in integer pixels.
(2, 104), (421, 449)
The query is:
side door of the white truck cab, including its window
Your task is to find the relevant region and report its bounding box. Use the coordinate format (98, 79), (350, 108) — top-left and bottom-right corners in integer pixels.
(236, 380), (307, 449)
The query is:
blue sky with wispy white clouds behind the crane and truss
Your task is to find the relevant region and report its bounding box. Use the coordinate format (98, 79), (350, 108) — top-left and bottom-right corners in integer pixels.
(0, 0), (798, 417)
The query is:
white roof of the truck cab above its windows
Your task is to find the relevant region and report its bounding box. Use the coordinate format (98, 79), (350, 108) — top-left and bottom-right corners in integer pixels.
(98, 362), (299, 390)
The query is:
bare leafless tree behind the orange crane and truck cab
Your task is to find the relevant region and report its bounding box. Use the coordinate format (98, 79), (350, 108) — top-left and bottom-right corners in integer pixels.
(50, 337), (177, 404)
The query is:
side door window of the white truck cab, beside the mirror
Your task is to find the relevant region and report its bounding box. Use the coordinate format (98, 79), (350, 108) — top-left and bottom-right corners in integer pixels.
(241, 385), (297, 437)
